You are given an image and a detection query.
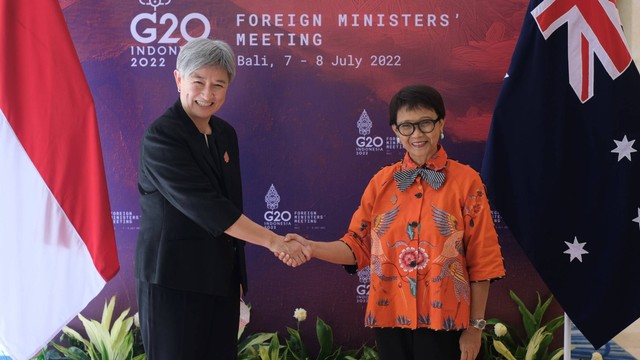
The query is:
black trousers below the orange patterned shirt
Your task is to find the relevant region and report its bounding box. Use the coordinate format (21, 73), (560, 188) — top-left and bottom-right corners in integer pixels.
(374, 328), (462, 360)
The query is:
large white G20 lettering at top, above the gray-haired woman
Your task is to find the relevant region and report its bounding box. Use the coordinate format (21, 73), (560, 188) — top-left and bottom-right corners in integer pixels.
(129, 12), (211, 44)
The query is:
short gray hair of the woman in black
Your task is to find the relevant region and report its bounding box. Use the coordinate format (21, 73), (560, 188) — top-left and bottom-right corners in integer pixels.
(176, 38), (236, 82)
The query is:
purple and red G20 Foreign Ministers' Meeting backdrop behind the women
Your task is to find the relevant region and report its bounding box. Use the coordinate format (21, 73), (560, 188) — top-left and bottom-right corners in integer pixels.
(60, 0), (561, 347)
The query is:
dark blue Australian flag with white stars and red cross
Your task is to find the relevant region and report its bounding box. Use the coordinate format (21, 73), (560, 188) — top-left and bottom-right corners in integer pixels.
(482, 0), (640, 348)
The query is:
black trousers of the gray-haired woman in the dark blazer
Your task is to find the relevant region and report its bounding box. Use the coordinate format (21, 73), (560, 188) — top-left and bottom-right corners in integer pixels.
(137, 280), (240, 360)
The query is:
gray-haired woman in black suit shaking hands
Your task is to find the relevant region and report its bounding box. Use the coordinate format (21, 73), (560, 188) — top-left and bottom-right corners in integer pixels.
(135, 39), (306, 360)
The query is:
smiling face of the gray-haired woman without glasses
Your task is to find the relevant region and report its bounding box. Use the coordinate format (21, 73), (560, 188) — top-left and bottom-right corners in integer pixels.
(173, 66), (229, 125)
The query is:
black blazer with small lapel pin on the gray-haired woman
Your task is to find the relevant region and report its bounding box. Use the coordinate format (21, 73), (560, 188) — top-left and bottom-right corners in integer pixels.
(135, 100), (247, 295)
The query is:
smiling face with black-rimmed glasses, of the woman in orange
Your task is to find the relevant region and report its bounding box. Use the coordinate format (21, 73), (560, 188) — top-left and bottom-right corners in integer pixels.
(391, 107), (444, 165)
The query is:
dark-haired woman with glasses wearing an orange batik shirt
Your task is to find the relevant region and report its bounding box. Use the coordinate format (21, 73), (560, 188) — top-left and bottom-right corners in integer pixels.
(280, 85), (505, 360)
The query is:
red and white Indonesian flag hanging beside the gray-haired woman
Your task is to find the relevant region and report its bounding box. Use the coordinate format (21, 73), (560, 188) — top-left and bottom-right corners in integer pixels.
(0, 0), (119, 360)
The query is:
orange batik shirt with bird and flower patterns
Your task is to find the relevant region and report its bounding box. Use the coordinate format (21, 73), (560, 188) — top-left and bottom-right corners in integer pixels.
(341, 146), (505, 330)
